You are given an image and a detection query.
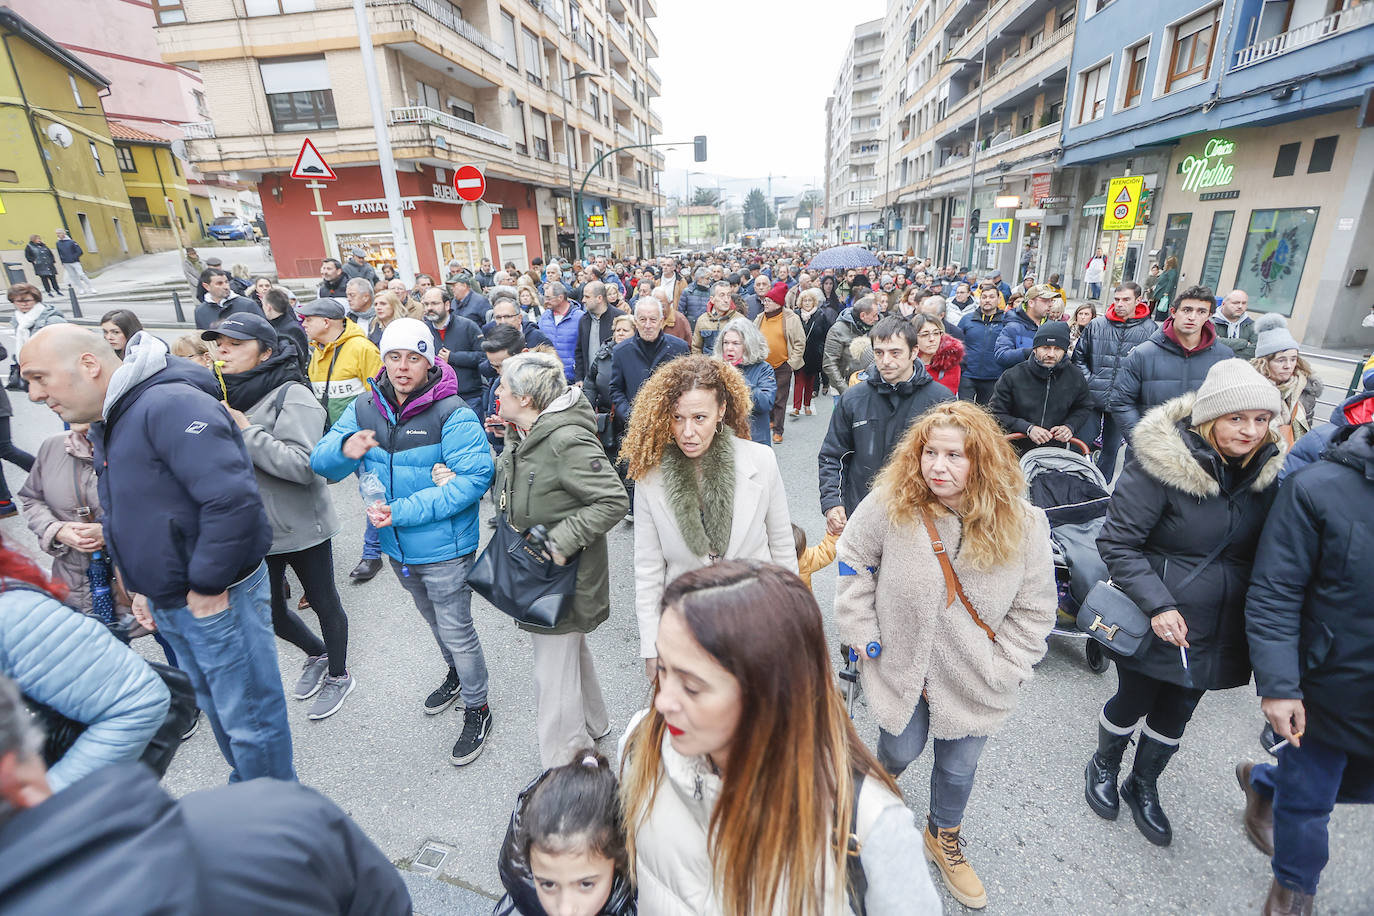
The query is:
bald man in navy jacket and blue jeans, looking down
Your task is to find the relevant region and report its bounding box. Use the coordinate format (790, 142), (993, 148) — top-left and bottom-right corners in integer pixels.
(19, 324), (295, 783)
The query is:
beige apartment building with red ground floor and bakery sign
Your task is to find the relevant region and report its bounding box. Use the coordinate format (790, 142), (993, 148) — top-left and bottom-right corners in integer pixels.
(157, 0), (662, 277)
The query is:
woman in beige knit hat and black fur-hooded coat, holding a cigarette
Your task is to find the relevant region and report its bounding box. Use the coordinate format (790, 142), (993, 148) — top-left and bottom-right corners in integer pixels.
(1084, 360), (1283, 846)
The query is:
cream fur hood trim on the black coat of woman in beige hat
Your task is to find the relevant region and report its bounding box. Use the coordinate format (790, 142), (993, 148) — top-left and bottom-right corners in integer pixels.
(1131, 391), (1287, 499)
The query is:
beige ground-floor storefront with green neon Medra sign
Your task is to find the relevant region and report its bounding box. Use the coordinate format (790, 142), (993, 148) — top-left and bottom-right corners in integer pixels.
(1154, 110), (1370, 343)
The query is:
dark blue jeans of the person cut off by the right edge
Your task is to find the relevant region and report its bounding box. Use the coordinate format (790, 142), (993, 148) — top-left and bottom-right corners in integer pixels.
(1250, 737), (1374, 894)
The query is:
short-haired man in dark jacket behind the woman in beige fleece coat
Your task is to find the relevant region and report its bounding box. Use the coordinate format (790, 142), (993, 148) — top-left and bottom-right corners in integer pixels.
(818, 316), (954, 534)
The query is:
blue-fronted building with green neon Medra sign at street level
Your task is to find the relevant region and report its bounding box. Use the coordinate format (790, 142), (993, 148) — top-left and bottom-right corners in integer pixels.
(1061, 0), (1374, 346)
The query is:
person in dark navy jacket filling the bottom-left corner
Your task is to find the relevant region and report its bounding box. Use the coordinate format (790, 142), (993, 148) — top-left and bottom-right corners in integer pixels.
(0, 677), (411, 916)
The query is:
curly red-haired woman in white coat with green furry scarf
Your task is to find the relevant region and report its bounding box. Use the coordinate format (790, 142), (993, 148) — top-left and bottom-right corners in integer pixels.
(620, 354), (797, 677)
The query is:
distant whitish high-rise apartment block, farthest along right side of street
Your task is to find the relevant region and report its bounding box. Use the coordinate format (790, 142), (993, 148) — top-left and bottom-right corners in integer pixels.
(826, 19), (886, 243)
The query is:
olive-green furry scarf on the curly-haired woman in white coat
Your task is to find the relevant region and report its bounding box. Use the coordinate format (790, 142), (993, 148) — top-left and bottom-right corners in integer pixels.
(661, 428), (735, 563)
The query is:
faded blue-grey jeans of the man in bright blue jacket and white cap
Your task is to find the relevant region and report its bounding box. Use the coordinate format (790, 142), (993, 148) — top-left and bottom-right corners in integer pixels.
(392, 553), (486, 706)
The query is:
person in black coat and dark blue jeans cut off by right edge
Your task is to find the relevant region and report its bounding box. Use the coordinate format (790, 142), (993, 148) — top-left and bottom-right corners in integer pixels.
(1237, 423), (1374, 913)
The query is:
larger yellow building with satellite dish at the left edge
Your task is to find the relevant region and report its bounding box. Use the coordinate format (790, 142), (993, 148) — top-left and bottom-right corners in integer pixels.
(0, 7), (143, 283)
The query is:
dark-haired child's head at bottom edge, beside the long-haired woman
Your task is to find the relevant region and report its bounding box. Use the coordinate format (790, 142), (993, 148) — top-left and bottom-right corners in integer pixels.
(496, 748), (636, 916)
